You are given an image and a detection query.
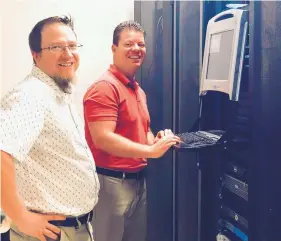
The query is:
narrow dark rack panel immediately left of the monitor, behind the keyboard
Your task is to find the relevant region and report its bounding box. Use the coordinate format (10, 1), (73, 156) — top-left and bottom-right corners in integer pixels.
(174, 1), (201, 241)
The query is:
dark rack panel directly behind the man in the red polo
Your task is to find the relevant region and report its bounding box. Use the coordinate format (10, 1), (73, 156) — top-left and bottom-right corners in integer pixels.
(135, 1), (174, 241)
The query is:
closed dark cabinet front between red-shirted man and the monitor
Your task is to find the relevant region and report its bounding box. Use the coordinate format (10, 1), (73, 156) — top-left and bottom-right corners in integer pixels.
(135, 1), (201, 241)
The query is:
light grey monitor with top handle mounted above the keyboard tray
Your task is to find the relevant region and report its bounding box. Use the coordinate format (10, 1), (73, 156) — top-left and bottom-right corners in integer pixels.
(200, 9), (248, 101)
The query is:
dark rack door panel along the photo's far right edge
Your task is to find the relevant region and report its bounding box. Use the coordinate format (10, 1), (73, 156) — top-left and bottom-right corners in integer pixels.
(249, 1), (281, 241)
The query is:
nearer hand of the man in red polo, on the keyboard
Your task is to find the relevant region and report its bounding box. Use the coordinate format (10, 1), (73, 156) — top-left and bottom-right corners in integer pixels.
(149, 132), (181, 158)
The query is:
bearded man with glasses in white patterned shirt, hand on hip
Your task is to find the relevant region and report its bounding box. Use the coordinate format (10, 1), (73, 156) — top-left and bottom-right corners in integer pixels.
(0, 17), (99, 241)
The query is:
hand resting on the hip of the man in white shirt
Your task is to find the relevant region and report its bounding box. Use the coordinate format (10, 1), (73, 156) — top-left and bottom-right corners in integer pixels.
(15, 211), (66, 241)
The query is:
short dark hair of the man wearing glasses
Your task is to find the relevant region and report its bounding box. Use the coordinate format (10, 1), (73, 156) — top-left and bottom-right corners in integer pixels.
(28, 16), (76, 53)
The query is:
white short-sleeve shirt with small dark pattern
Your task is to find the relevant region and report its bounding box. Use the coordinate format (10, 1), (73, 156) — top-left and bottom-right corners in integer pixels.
(0, 67), (99, 216)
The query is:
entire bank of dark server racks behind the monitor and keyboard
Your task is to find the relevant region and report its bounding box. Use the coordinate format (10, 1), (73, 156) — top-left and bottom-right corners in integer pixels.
(135, 1), (281, 241)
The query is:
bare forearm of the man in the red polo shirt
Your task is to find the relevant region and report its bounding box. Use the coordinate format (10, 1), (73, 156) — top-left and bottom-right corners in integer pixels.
(95, 132), (153, 158)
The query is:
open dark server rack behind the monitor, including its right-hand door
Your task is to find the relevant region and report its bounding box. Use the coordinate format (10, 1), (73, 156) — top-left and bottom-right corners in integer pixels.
(199, 1), (281, 241)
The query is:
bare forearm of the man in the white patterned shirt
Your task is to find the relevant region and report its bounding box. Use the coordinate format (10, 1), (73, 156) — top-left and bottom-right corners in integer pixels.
(1, 151), (27, 223)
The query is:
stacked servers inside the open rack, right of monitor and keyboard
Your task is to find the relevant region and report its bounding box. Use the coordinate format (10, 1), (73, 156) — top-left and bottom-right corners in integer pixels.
(217, 6), (248, 241)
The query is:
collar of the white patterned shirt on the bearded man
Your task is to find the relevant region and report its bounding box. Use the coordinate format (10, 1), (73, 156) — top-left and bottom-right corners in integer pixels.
(31, 66), (74, 103)
